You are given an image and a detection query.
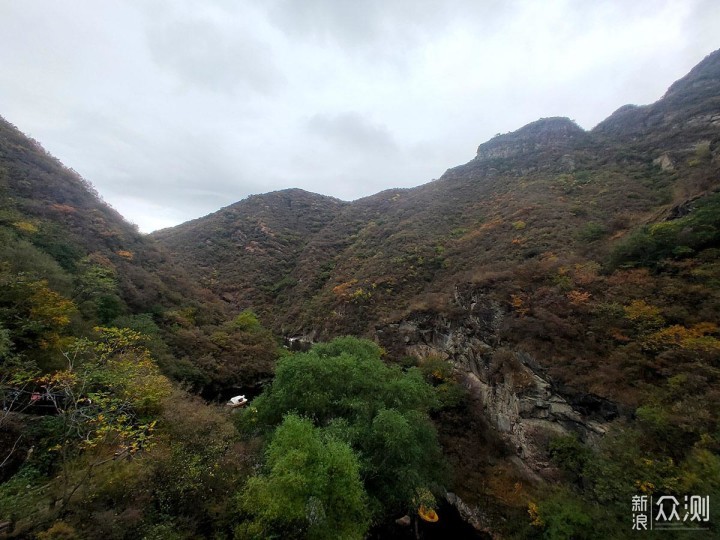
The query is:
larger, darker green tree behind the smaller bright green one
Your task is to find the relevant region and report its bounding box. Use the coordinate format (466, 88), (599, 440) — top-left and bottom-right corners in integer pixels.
(240, 337), (443, 533)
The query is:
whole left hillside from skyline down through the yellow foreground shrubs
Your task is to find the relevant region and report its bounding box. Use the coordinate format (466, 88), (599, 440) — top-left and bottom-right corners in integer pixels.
(0, 116), (278, 538)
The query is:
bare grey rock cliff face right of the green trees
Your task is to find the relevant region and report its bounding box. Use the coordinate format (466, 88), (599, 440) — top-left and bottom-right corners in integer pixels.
(377, 285), (617, 476)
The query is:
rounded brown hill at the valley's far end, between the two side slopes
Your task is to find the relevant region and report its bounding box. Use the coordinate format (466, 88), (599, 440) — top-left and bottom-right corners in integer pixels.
(153, 189), (346, 309)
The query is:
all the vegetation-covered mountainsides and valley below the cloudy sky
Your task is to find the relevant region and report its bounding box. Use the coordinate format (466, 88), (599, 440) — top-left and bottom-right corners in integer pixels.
(0, 51), (720, 539)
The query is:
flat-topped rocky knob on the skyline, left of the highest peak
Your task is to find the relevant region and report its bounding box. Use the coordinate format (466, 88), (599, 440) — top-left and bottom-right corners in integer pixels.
(475, 116), (587, 161)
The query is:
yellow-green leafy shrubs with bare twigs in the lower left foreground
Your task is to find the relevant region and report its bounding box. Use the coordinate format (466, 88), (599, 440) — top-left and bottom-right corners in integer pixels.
(0, 328), (170, 520)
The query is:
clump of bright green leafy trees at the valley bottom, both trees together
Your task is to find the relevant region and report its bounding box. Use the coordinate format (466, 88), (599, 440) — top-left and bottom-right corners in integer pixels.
(239, 337), (443, 538)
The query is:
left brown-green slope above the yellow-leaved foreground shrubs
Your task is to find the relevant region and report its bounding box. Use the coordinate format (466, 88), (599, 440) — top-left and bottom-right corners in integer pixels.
(0, 119), (275, 390)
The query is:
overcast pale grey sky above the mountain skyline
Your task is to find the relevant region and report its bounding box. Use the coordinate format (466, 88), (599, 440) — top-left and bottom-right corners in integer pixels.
(0, 0), (720, 232)
